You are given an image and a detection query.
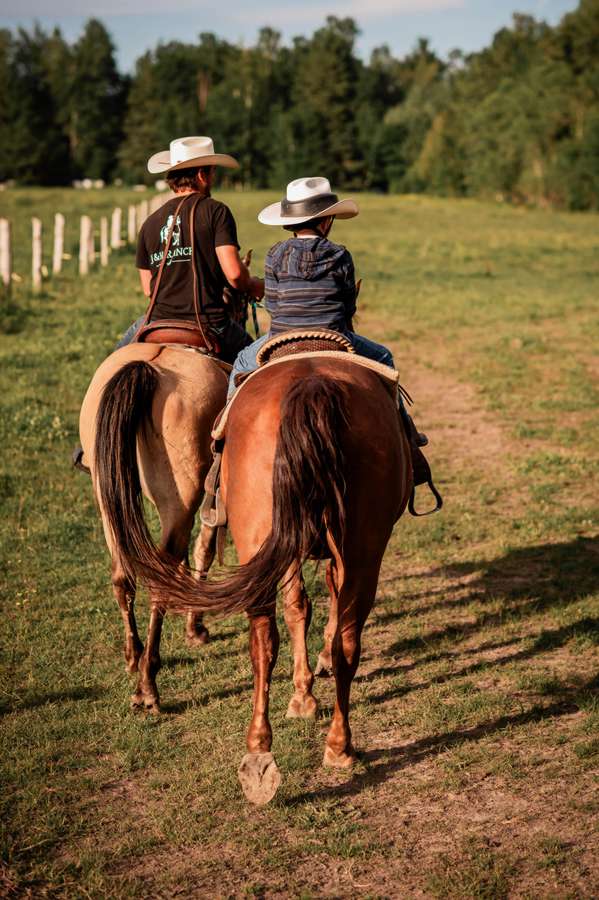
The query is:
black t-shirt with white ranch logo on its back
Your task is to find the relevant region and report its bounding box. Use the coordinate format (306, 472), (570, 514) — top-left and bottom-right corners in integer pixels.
(135, 194), (239, 330)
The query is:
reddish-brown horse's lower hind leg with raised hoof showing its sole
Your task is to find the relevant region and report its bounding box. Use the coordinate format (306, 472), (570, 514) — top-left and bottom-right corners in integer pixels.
(238, 602), (281, 805)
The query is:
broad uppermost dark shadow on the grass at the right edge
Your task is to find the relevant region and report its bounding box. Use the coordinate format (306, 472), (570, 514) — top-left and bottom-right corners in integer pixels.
(385, 537), (599, 656)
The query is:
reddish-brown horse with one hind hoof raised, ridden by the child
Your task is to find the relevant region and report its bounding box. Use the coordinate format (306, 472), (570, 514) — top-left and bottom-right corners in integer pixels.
(119, 354), (413, 803)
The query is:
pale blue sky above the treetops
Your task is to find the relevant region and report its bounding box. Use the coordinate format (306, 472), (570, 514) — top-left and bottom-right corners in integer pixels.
(0, 0), (578, 72)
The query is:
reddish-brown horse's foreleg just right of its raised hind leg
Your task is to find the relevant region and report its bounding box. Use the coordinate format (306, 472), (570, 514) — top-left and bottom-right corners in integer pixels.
(283, 571), (318, 719)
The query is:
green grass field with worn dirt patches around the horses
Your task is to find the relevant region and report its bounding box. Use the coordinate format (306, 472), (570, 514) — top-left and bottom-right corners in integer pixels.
(0, 190), (599, 900)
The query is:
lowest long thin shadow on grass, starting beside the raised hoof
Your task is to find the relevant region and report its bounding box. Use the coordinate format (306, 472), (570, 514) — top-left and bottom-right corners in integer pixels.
(287, 677), (599, 806)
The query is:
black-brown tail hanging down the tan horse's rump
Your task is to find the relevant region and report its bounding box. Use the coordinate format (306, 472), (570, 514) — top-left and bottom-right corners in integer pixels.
(94, 361), (170, 578)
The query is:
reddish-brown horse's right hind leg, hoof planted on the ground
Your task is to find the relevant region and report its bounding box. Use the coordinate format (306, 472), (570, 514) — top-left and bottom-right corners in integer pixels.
(323, 567), (378, 768)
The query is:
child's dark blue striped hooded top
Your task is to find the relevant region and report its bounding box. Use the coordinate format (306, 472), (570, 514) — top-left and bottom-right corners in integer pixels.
(264, 235), (356, 334)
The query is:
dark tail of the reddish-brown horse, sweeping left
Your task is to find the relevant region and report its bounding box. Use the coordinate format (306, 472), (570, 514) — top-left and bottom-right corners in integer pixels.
(149, 376), (347, 614)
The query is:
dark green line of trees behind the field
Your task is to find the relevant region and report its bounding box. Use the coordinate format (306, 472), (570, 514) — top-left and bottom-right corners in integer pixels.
(0, 0), (599, 209)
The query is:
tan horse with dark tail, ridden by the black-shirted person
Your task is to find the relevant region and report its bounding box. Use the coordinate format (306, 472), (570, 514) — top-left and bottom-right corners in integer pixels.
(80, 344), (230, 712)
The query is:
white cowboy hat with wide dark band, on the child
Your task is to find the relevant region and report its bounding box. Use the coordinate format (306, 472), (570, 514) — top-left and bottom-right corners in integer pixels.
(258, 178), (359, 225)
